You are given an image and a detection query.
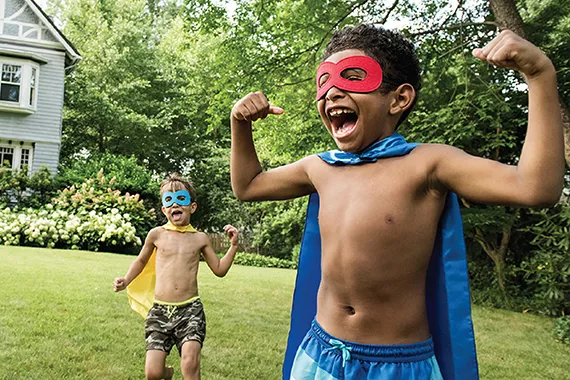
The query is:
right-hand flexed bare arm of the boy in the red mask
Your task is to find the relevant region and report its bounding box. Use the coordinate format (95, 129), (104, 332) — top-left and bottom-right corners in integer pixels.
(430, 31), (564, 206)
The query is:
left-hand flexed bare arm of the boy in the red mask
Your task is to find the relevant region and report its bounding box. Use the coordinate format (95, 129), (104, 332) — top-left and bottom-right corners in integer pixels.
(230, 92), (315, 201)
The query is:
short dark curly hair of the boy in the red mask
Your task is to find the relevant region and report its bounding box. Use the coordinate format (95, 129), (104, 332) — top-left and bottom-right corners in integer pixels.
(323, 24), (422, 126)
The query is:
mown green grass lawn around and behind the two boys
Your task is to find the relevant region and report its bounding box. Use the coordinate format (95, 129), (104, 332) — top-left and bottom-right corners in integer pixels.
(0, 247), (570, 380)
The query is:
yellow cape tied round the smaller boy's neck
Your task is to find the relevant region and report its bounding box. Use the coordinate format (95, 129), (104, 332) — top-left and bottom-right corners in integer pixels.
(127, 222), (198, 318)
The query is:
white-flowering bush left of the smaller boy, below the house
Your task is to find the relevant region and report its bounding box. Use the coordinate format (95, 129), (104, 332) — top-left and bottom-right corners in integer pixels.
(0, 171), (156, 252)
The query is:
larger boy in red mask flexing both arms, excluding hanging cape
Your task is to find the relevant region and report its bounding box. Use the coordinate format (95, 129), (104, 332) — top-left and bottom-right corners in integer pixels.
(231, 25), (564, 380)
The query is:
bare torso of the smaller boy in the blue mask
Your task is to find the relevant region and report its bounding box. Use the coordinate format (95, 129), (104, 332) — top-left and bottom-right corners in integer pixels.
(150, 228), (206, 302)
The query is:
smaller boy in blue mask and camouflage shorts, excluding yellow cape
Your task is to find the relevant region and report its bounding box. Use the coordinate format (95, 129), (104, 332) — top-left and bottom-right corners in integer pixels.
(114, 175), (238, 380)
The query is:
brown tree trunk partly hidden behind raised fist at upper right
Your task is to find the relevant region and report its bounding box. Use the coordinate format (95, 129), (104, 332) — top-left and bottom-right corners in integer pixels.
(489, 0), (570, 166)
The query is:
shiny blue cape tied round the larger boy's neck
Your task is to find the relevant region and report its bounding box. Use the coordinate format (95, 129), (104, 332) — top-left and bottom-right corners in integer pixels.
(283, 133), (479, 380)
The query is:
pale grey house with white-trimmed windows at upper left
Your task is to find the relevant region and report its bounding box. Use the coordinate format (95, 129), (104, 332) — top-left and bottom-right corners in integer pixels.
(0, 0), (81, 173)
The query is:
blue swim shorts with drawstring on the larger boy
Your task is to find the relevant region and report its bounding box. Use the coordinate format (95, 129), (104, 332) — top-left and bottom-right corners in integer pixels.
(291, 321), (443, 380)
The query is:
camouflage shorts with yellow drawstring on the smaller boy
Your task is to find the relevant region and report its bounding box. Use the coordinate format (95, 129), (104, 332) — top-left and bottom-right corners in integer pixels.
(145, 298), (206, 353)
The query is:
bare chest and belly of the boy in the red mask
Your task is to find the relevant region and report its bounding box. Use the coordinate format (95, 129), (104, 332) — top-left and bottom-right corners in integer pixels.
(310, 148), (445, 344)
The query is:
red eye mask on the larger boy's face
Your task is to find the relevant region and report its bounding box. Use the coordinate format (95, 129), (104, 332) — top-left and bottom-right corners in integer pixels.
(317, 55), (382, 100)
